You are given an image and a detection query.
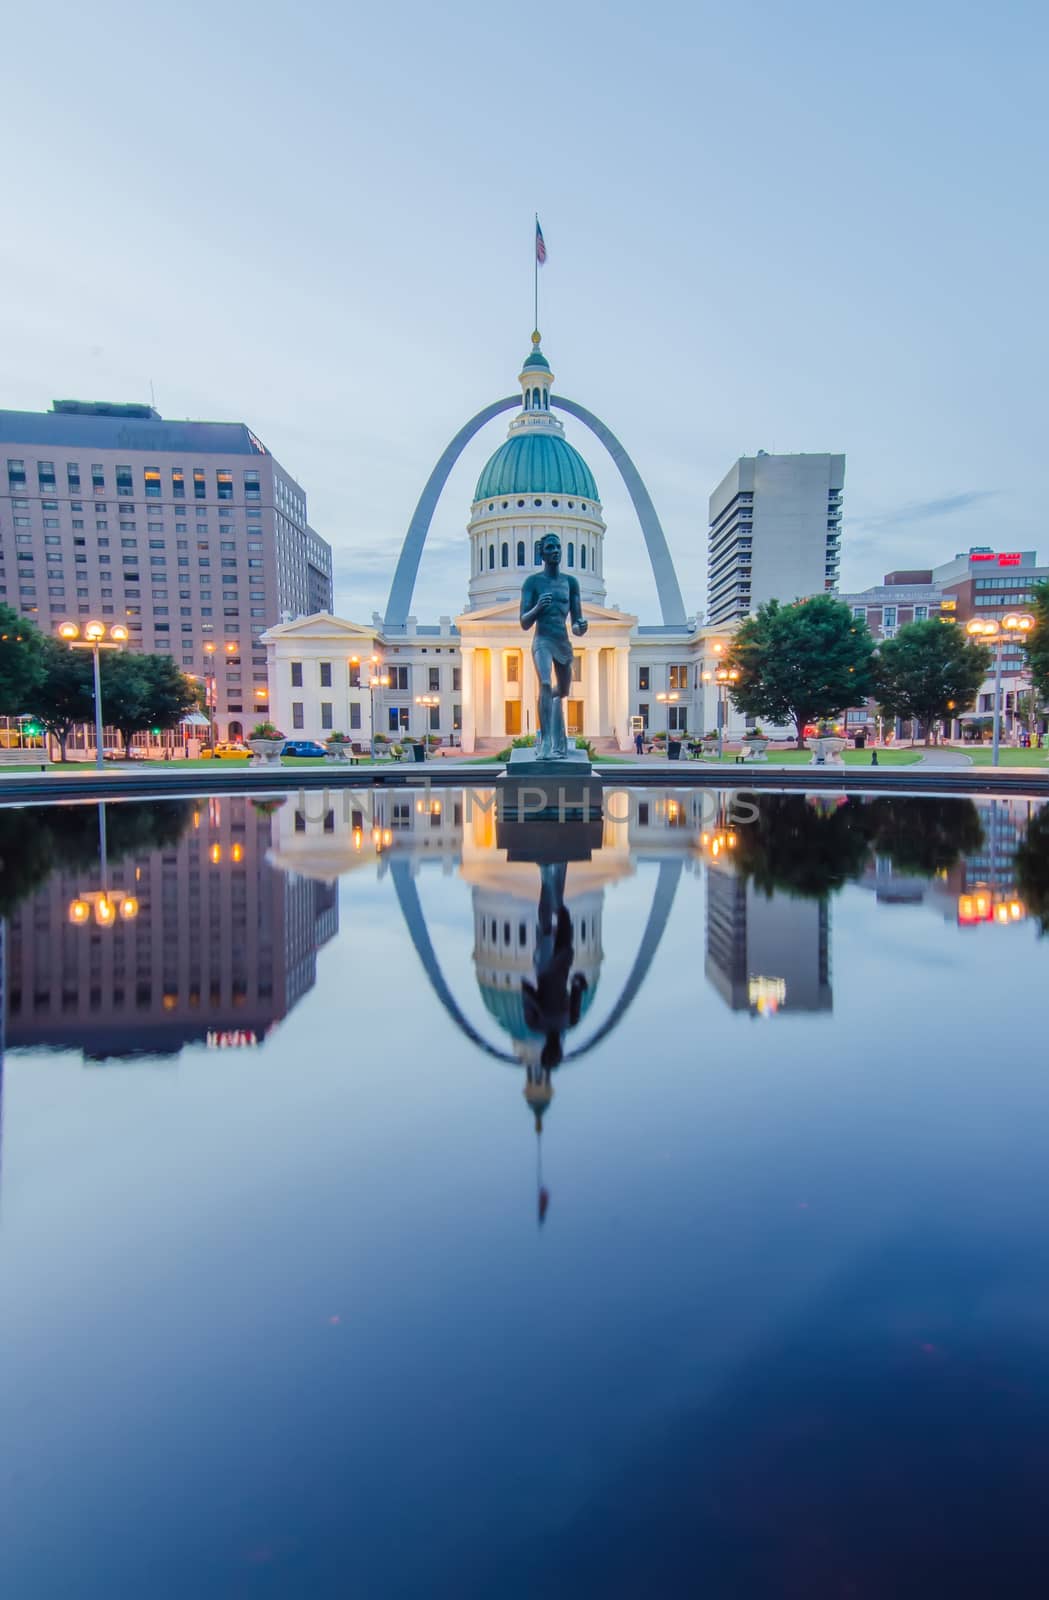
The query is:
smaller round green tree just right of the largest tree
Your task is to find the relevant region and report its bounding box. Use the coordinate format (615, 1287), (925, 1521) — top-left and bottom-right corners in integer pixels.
(875, 621), (991, 744)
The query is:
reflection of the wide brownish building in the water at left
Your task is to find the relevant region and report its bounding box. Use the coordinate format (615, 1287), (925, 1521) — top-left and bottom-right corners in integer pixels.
(6, 797), (339, 1061)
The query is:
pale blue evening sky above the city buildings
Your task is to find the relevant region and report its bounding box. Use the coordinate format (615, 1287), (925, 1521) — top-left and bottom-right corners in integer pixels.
(0, 0), (1049, 621)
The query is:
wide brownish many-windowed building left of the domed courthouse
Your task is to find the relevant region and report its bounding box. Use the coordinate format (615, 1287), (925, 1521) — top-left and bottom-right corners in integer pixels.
(0, 400), (333, 738)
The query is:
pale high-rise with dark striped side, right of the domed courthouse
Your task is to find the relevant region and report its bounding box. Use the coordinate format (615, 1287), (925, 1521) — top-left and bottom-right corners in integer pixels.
(707, 450), (844, 626)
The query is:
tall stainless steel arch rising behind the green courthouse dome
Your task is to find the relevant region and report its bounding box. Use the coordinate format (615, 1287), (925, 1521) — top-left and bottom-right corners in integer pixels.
(384, 394), (686, 632)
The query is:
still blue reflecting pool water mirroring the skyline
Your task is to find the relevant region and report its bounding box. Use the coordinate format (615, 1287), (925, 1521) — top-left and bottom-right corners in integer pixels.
(0, 790), (1049, 1600)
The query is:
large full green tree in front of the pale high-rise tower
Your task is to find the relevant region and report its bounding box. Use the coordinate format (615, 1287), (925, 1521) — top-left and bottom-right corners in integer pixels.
(728, 595), (875, 749)
